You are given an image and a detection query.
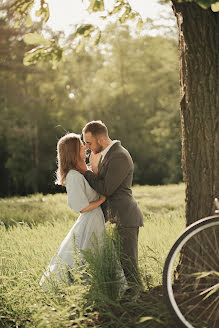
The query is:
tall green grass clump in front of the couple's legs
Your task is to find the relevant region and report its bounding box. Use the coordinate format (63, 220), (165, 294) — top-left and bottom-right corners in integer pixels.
(83, 222), (127, 302)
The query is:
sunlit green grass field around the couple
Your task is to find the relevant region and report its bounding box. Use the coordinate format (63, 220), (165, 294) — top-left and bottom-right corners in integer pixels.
(0, 184), (185, 328)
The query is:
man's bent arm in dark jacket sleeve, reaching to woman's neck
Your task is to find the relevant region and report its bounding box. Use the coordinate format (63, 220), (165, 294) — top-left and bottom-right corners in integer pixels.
(84, 154), (130, 197)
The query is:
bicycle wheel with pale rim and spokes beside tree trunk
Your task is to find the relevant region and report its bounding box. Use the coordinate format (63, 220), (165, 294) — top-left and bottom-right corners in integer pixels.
(163, 216), (219, 328)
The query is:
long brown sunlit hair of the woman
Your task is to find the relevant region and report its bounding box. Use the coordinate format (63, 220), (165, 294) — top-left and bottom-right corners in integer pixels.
(55, 133), (81, 186)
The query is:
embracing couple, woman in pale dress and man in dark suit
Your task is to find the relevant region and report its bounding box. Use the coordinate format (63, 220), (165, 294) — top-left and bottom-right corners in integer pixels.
(40, 121), (143, 290)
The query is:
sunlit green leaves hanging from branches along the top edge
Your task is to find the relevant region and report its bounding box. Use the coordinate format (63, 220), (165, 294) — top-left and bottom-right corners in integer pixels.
(3, 0), (219, 68)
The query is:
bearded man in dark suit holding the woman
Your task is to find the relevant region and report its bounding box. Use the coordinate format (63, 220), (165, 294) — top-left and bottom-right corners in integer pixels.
(78, 121), (143, 288)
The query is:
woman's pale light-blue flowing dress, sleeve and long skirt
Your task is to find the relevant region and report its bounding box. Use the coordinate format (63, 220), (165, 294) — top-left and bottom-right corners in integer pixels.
(40, 170), (105, 288)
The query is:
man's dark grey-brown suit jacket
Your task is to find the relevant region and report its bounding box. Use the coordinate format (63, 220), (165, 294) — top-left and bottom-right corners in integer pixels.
(84, 141), (143, 227)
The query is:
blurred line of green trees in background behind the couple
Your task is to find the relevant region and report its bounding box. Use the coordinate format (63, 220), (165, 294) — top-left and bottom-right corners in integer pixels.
(0, 7), (182, 197)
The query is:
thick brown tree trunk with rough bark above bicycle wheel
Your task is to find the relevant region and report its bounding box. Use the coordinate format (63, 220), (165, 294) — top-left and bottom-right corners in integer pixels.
(172, 0), (219, 225)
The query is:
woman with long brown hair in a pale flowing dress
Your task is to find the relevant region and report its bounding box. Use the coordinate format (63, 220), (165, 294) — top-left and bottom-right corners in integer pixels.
(40, 133), (105, 286)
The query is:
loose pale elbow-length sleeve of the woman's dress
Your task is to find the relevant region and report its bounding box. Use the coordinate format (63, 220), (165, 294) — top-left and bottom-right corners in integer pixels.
(66, 170), (89, 212)
